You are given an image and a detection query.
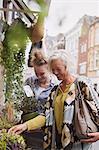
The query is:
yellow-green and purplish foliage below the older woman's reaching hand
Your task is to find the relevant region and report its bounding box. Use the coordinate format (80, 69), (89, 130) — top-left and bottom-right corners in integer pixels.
(0, 130), (26, 150)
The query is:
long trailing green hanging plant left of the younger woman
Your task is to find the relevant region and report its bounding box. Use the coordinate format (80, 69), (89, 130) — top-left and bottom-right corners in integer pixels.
(1, 19), (29, 112)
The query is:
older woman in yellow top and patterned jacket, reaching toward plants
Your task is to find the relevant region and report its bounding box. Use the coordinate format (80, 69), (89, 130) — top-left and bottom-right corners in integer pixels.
(9, 50), (99, 150)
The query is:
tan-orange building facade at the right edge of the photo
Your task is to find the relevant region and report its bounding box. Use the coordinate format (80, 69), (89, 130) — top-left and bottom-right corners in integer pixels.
(87, 18), (99, 83)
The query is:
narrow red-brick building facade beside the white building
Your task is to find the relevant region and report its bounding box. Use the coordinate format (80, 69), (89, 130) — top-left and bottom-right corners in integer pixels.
(77, 17), (91, 76)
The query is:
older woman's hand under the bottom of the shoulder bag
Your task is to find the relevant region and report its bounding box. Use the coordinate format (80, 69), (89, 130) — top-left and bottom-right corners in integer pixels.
(81, 132), (99, 143)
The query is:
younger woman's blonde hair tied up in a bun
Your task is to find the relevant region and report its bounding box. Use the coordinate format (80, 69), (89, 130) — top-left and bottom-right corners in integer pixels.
(30, 48), (48, 66)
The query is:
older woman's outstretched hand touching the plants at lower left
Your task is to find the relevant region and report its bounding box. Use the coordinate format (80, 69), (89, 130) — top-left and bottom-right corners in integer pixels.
(8, 123), (27, 134)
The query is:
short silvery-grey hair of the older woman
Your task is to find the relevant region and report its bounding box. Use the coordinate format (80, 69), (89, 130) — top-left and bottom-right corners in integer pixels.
(49, 49), (72, 72)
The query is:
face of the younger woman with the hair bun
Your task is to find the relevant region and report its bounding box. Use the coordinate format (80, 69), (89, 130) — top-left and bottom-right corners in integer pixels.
(34, 65), (48, 83)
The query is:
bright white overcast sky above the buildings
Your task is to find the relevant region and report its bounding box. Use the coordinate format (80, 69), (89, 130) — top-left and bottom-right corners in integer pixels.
(45, 0), (99, 36)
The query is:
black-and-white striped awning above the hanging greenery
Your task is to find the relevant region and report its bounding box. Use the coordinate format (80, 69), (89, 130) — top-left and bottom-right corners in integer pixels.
(0, 0), (51, 23)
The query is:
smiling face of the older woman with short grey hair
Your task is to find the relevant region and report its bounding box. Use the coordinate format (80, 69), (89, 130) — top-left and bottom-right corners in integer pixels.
(51, 59), (67, 80)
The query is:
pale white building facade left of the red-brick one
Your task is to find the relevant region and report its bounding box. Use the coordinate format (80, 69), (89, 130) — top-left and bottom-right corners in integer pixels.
(65, 17), (82, 74)
